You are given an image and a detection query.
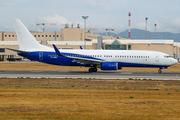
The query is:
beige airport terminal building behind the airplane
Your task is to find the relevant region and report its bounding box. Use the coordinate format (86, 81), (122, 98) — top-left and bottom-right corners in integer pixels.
(0, 28), (180, 61)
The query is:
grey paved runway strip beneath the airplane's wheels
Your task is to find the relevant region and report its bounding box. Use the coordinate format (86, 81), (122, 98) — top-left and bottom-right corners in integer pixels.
(0, 70), (180, 80)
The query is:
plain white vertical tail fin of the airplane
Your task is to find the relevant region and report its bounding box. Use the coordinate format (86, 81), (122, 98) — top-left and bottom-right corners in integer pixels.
(14, 19), (46, 51)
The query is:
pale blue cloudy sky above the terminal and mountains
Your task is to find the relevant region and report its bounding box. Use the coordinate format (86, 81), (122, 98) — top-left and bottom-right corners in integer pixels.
(0, 0), (180, 33)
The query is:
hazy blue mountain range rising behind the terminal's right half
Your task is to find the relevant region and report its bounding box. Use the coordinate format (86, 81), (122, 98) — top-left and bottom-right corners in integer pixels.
(98, 28), (180, 42)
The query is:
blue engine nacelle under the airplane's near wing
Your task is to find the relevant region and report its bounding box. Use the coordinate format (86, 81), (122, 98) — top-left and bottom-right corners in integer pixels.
(101, 62), (118, 70)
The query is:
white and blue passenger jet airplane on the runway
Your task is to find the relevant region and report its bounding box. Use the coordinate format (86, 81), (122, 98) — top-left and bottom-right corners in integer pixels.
(7, 19), (178, 73)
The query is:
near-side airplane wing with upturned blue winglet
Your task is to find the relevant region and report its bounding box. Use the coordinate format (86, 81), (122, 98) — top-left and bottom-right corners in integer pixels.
(53, 44), (103, 65)
